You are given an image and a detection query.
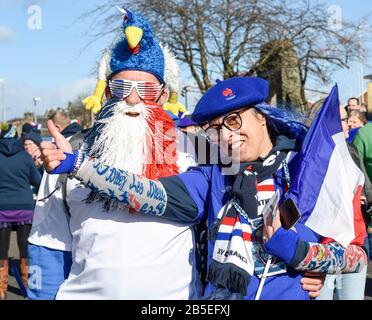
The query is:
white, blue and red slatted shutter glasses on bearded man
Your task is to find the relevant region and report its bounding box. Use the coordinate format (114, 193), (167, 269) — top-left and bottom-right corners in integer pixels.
(109, 79), (164, 101)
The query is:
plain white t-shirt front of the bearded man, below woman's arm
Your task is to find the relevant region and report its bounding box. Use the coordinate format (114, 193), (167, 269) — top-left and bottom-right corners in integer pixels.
(56, 188), (200, 300)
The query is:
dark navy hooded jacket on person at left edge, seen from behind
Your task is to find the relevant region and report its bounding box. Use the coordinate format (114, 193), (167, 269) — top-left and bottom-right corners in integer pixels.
(0, 139), (41, 210)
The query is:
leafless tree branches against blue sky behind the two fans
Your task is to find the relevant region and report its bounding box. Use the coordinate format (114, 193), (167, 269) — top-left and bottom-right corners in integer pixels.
(79, 0), (370, 111)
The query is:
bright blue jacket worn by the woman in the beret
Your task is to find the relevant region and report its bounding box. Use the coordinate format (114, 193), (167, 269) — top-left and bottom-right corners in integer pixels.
(160, 151), (321, 300)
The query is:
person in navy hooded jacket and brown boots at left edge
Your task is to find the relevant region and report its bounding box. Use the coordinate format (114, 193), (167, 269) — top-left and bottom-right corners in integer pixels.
(0, 125), (41, 300)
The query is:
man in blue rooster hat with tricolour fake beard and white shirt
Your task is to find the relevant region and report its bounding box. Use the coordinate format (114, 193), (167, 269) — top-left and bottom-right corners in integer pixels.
(28, 9), (201, 299)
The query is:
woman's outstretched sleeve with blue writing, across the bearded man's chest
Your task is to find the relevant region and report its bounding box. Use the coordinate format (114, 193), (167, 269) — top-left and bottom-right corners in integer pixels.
(76, 158), (208, 223)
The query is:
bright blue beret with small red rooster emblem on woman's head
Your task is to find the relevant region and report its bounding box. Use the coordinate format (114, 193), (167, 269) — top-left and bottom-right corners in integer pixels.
(192, 77), (269, 123)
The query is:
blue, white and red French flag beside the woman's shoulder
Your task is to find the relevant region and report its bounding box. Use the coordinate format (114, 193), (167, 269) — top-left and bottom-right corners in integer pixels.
(288, 85), (365, 247)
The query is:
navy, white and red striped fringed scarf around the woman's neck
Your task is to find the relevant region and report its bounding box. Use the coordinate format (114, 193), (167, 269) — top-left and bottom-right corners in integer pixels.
(207, 148), (286, 295)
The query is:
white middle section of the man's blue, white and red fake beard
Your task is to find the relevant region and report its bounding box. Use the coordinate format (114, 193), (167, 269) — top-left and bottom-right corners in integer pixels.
(90, 101), (149, 174)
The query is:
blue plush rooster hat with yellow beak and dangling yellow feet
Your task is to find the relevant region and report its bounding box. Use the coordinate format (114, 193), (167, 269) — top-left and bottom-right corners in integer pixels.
(83, 7), (185, 115)
